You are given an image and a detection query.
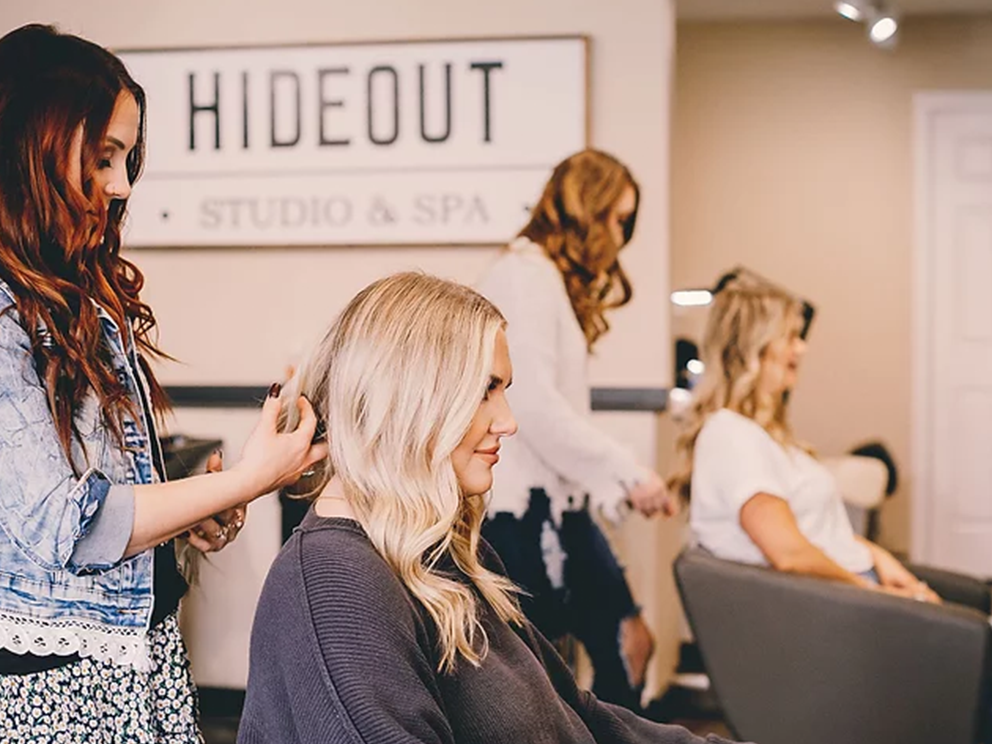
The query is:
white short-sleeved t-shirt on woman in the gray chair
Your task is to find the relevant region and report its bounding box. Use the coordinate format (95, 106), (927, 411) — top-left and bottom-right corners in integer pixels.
(689, 408), (873, 573)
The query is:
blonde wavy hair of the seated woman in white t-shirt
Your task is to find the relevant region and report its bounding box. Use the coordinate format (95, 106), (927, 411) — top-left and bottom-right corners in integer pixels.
(668, 271), (808, 500)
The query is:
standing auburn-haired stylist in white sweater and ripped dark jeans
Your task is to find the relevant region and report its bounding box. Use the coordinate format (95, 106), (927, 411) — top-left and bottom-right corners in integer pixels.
(479, 150), (676, 710)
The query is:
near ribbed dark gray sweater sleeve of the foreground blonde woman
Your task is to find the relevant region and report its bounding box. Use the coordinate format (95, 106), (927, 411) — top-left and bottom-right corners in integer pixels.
(297, 536), (454, 744)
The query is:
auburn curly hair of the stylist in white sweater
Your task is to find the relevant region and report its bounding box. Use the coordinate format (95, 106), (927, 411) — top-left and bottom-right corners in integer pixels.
(520, 149), (640, 350)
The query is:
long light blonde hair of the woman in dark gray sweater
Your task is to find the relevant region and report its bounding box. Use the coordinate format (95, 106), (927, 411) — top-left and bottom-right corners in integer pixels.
(282, 273), (524, 672)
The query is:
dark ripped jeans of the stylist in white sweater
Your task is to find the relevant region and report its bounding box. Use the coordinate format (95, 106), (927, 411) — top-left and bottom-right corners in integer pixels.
(482, 489), (640, 710)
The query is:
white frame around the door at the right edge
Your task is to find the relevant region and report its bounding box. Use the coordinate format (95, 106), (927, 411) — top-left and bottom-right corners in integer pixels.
(910, 90), (992, 562)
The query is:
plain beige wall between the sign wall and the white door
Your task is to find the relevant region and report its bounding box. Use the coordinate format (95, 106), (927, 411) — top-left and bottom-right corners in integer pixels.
(671, 16), (992, 550)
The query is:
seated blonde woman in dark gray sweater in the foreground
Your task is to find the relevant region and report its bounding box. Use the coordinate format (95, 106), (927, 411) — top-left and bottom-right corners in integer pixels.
(238, 274), (740, 744)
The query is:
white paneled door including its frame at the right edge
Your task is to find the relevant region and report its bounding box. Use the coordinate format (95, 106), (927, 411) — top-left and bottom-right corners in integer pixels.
(913, 93), (992, 577)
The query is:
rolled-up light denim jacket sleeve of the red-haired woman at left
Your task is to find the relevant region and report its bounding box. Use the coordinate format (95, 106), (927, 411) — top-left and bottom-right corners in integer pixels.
(0, 306), (121, 573)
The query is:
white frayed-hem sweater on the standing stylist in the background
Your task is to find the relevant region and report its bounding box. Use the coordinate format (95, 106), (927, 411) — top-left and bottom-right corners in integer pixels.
(477, 238), (647, 520)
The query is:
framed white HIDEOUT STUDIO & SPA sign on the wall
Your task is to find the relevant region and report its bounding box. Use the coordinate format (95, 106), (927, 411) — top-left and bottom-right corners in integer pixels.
(120, 36), (588, 247)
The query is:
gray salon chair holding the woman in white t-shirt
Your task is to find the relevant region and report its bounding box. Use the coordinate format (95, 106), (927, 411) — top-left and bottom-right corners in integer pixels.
(675, 548), (992, 744)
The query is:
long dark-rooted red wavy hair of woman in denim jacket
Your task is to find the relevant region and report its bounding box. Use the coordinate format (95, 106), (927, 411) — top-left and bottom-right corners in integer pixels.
(0, 24), (168, 470)
